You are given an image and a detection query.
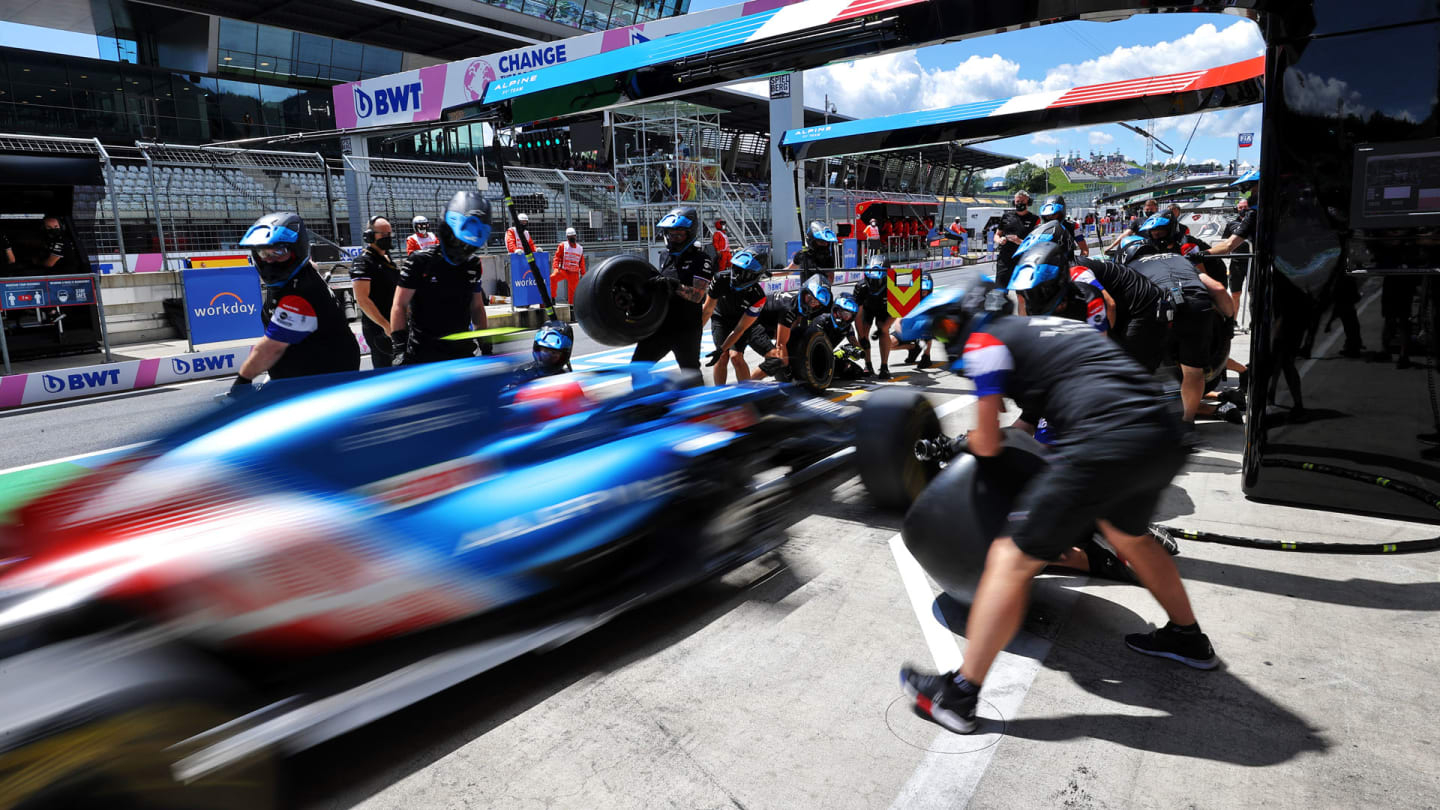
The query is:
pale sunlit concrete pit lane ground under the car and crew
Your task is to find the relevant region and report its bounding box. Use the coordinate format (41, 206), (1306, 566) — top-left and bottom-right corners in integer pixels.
(0, 266), (1440, 810)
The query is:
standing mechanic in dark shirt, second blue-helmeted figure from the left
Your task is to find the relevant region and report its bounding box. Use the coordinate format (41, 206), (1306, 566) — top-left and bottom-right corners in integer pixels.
(390, 190), (490, 365)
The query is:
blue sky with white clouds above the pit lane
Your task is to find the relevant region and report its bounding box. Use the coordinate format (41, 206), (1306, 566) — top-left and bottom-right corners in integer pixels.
(690, 0), (1264, 176)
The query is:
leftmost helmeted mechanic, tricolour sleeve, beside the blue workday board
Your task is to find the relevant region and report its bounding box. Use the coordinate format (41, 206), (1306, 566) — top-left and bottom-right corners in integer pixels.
(230, 212), (360, 396)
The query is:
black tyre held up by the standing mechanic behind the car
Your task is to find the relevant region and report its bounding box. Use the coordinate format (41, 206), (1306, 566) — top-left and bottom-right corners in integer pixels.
(575, 254), (670, 346)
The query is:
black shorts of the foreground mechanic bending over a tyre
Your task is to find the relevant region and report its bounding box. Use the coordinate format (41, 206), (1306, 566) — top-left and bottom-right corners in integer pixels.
(1001, 428), (1187, 559)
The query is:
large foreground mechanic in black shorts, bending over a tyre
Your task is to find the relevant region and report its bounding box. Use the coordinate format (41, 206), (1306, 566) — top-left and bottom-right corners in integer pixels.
(900, 289), (1218, 734)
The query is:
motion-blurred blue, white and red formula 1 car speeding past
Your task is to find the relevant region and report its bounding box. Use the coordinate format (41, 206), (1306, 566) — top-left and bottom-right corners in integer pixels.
(0, 359), (852, 809)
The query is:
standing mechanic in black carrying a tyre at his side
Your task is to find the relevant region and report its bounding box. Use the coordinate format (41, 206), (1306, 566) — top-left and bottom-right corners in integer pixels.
(631, 206), (716, 370)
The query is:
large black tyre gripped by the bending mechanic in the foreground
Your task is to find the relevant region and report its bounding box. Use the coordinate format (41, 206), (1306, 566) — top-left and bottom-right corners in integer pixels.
(900, 430), (1071, 604)
